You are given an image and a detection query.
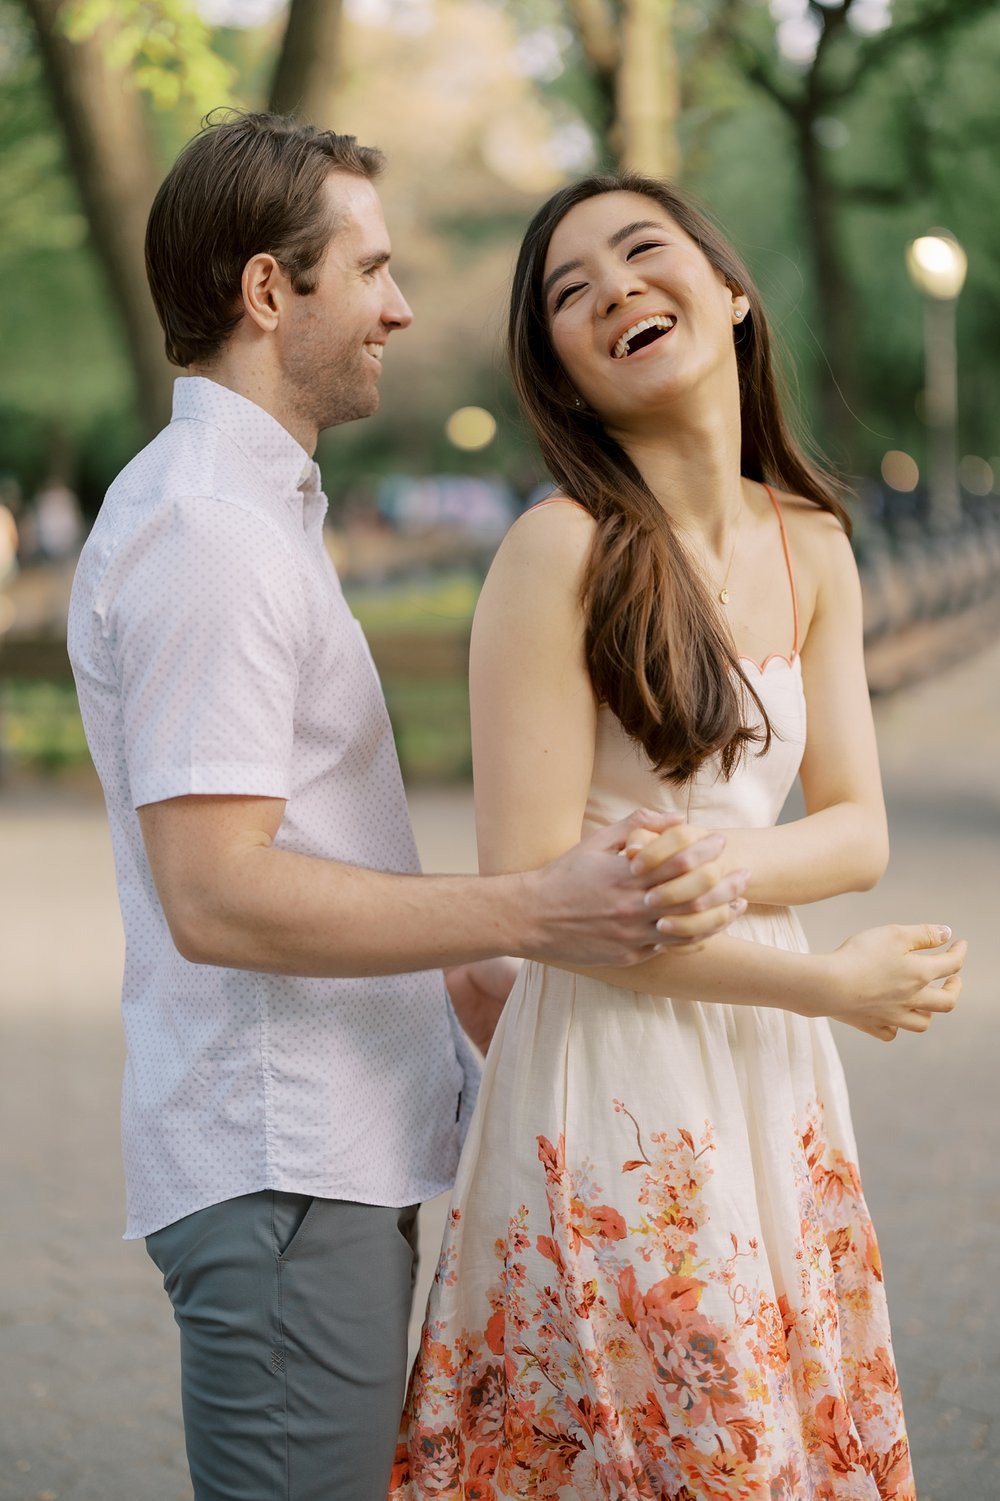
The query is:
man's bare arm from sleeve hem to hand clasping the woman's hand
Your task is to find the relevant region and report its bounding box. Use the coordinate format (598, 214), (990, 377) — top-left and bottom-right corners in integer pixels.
(138, 796), (740, 976)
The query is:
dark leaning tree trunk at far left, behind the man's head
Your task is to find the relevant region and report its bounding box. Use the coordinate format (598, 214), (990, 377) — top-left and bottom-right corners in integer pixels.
(26, 0), (173, 435)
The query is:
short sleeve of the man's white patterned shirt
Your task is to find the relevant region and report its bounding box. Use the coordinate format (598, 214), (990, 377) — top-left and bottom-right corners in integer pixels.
(105, 498), (309, 808)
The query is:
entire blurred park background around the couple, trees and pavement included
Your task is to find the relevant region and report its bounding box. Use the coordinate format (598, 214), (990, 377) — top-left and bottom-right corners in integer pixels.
(0, 0), (1000, 1501)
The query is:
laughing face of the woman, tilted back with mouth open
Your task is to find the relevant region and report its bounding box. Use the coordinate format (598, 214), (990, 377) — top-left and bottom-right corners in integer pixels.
(544, 192), (738, 429)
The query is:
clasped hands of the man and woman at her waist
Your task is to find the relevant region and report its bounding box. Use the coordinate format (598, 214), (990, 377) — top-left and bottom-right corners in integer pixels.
(524, 809), (748, 967)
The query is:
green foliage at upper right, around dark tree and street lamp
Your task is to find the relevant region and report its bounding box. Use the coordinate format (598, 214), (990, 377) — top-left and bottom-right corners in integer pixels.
(669, 0), (1000, 474)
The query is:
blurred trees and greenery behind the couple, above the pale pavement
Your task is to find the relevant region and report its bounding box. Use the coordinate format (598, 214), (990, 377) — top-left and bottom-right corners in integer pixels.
(0, 0), (1000, 779)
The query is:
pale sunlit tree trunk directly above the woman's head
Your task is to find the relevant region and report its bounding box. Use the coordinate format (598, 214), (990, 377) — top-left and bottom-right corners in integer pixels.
(617, 0), (680, 177)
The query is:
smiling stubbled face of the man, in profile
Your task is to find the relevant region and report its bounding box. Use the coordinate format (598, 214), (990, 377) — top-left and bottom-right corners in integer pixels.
(281, 171), (413, 431)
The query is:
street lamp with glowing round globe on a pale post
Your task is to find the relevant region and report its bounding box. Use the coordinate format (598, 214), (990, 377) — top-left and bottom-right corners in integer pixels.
(907, 230), (968, 531)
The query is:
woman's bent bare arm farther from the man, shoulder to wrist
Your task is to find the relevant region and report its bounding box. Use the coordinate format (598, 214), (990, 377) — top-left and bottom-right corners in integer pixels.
(640, 500), (889, 907)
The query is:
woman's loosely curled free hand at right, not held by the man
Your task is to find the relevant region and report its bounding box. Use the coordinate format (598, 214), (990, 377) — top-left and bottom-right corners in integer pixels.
(824, 925), (967, 1042)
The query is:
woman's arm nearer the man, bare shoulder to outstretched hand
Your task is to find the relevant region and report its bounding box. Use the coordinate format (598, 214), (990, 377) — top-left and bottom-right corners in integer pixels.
(470, 504), (964, 1036)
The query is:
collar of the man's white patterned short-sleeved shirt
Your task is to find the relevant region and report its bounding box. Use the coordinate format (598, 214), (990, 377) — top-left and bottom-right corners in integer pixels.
(173, 375), (326, 524)
